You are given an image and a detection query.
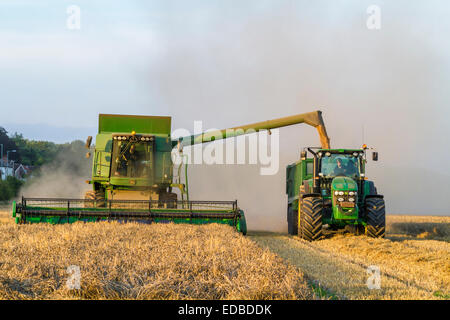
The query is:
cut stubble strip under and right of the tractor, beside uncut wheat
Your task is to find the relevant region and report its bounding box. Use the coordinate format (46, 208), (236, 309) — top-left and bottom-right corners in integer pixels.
(250, 216), (450, 299)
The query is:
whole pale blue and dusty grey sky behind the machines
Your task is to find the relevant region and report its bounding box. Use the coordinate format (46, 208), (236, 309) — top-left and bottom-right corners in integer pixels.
(0, 0), (450, 228)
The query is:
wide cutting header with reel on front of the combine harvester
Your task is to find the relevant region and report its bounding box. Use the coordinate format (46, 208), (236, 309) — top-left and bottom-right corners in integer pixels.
(13, 198), (245, 233)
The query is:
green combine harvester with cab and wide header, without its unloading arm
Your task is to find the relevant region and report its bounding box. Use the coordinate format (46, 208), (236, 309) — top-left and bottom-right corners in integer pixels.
(12, 114), (247, 234)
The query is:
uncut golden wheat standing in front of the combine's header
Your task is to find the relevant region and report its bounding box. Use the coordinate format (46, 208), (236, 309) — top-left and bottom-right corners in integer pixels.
(0, 208), (313, 299)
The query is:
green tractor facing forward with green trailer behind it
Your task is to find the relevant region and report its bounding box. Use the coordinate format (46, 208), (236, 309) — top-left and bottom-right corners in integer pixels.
(286, 145), (385, 241)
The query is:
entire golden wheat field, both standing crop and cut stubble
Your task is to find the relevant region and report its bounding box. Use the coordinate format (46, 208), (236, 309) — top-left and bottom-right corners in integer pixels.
(0, 205), (450, 299)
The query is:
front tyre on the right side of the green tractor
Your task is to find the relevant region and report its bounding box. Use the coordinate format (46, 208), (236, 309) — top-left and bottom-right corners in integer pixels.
(366, 198), (386, 238)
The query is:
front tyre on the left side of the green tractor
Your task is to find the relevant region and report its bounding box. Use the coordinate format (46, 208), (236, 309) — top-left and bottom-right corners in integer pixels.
(299, 197), (323, 241)
